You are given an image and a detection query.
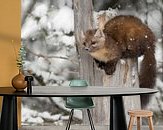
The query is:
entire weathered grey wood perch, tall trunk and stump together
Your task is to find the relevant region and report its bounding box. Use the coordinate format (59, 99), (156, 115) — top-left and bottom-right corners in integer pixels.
(74, 0), (140, 125)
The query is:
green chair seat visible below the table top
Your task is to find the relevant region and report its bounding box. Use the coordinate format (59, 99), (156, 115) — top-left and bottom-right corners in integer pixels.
(65, 97), (94, 109)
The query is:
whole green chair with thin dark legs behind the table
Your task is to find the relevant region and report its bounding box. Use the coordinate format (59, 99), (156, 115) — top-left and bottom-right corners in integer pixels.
(65, 79), (95, 130)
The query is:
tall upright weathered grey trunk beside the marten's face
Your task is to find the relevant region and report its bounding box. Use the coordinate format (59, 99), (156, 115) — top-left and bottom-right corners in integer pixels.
(74, 0), (105, 123)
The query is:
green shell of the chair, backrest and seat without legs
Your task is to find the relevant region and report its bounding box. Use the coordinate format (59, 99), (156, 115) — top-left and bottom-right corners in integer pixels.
(65, 79), (94, 109)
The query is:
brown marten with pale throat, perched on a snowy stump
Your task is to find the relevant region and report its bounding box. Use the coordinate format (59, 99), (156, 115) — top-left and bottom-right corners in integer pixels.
(83, 15), (156, 105)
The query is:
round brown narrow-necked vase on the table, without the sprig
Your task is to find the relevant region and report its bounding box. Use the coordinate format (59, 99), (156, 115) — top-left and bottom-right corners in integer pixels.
(12, 70), (27, 91)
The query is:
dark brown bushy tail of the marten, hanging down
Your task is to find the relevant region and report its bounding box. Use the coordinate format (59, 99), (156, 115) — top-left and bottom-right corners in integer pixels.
(139, 47), (156, 108)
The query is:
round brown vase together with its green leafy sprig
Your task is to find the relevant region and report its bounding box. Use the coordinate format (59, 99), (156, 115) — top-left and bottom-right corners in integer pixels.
(12, 46), (27, 91)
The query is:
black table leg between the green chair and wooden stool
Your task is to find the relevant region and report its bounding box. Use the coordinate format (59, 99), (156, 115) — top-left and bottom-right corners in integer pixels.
(110, 96), (127, 130)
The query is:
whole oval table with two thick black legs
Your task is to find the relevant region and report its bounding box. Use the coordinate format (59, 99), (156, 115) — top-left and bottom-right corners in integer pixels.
(0, 86), (158, 130)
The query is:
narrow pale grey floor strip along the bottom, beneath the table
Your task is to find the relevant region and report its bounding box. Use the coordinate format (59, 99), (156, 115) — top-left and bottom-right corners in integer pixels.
(19, 125), (163, 130)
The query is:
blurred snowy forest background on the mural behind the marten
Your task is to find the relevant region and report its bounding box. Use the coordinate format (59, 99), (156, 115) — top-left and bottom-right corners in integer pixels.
(21, 0), (163, 125)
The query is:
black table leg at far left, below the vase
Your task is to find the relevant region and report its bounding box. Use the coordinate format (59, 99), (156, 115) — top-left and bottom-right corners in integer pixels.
(0, 96), (18, 130)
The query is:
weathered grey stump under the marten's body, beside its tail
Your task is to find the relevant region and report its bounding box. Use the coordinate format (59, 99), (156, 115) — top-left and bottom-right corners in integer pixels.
(103, 58), (140, 122)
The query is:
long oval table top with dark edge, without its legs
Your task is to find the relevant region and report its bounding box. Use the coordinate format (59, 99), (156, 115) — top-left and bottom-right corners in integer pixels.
(0, 86), (158, 97)
